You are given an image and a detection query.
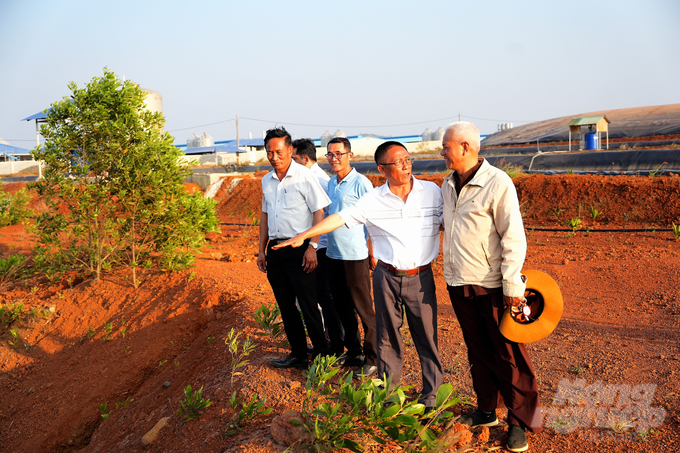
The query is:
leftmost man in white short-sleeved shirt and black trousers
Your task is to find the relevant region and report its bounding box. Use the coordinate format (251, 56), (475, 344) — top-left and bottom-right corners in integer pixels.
(257, 128), (330, 368)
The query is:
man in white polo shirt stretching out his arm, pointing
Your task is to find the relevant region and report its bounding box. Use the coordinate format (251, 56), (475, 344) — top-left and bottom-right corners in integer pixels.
(276, 141), (444, 410)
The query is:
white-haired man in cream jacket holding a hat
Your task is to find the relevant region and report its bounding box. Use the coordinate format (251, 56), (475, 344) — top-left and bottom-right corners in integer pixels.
(441, 122), (542, 451)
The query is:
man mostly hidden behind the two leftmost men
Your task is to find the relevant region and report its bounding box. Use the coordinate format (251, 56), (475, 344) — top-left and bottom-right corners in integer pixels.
(293, 138), (344, 357)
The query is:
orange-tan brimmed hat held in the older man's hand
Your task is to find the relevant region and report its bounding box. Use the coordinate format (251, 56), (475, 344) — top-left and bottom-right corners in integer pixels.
(500, 270), (562, 343)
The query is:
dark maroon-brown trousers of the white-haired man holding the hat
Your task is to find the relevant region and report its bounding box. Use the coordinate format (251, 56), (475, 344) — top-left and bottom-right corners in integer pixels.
(448, 286), (542, 433)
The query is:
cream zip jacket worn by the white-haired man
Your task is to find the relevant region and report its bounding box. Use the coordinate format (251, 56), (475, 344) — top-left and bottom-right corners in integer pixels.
(442, 159), (527, 297)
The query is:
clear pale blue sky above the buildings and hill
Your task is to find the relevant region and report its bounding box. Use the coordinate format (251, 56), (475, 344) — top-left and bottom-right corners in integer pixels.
(0, 0), (680, 148)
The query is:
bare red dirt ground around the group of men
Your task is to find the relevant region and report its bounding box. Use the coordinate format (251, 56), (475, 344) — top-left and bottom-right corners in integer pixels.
(0, 175), (680, 453)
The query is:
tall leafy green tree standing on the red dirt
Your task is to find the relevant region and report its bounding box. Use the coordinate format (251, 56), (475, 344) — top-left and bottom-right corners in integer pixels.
(32, 68), (218, 286)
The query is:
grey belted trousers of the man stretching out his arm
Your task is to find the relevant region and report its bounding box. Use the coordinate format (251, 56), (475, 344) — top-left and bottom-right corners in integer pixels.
(373, 266), (444, 406)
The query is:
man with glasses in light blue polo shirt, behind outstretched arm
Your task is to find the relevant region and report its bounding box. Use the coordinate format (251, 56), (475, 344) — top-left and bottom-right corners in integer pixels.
(326, 137), (378, 376)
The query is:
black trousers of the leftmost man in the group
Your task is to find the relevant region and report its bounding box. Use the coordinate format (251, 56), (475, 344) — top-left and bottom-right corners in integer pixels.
(267, 241), (329, 359)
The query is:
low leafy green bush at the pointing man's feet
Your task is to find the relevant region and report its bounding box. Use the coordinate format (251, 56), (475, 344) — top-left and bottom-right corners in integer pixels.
(294, 356), (461, 452)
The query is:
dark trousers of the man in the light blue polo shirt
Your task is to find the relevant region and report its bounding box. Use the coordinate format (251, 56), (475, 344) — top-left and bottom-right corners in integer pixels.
(328, 258), (377, 365)
